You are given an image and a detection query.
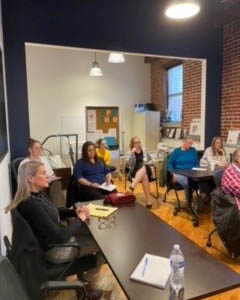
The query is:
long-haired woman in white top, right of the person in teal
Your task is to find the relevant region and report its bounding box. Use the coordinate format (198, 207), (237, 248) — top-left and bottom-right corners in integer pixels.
(200, 136), (228, 167)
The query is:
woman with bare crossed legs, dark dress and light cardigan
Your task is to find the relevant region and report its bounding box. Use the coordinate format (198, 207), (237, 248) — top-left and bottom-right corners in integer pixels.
(126, 136), (152, 208)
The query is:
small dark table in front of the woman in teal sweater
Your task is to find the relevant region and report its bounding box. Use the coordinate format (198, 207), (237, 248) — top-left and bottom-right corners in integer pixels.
(172, 169), (213, 226)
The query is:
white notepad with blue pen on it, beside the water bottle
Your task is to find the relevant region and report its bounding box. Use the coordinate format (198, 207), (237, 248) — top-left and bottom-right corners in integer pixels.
(130, 253), (171, 288)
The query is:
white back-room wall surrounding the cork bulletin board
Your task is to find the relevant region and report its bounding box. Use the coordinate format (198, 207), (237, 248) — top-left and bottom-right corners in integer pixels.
(25, 44), (150, 157)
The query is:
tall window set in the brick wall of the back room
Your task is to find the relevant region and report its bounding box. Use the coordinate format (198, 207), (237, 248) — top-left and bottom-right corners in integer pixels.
(167, 65), (183, 122)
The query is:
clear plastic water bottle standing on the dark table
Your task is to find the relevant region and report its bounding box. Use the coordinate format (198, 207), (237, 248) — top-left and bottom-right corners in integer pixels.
(169, 245), (184, 300)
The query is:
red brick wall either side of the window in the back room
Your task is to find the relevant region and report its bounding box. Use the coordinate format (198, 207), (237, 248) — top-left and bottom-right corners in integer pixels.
(151, 59), (202, 129)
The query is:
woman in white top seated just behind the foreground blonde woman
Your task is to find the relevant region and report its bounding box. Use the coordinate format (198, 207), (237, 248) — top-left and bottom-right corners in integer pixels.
(19, 138), (65, 207)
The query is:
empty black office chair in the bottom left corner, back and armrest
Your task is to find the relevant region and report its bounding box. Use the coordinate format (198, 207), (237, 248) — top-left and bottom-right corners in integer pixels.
(0, 256), (86, 300)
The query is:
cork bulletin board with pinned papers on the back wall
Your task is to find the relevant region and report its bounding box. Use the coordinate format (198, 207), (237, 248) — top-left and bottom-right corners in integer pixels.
(86, 106), (119, 145)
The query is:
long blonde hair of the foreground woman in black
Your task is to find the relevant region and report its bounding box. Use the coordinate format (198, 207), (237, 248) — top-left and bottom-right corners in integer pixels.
(5, 161), (43, 213)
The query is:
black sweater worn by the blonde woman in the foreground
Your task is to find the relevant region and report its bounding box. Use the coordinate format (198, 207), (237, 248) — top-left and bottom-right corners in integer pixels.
(18, 192), (82, 251)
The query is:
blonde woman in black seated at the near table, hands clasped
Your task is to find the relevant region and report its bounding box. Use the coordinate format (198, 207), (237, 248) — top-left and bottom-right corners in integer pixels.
(6, 161), (102, 299)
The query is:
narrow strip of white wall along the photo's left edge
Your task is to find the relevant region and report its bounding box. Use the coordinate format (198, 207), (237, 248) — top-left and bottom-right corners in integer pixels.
(0, 3), (12, 255)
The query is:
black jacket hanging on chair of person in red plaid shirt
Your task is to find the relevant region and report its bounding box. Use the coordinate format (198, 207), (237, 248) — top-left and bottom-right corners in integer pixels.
(212, 188), (240, 257)
